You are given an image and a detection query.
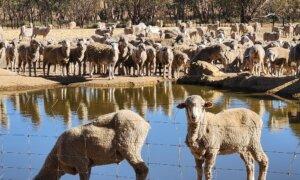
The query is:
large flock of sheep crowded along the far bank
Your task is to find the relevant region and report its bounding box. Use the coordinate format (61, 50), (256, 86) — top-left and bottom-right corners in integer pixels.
(0, 19), (300, 79)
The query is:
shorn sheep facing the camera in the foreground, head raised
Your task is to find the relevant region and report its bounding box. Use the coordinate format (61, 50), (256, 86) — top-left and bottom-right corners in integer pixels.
(177, 95), (269, 180)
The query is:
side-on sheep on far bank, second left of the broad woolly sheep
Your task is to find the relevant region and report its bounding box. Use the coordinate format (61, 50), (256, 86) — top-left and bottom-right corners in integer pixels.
(43, 40), (71, 76)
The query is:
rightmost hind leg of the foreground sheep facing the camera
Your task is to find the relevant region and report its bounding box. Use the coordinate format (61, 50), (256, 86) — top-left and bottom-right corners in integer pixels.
(251, 144), (269, 180)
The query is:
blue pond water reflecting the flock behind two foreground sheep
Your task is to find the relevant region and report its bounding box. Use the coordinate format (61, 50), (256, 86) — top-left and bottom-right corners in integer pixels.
(0, 83), (300, 180)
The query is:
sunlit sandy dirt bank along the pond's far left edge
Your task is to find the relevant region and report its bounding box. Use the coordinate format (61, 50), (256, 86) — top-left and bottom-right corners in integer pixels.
(0, 69), (163, 91)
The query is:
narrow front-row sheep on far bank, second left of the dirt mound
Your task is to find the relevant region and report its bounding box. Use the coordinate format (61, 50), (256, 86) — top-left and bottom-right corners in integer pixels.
(157, 47), (174, 79)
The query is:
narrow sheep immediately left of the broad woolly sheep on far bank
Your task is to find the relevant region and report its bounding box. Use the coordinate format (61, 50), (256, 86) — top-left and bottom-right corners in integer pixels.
(67, 40), (87, 76)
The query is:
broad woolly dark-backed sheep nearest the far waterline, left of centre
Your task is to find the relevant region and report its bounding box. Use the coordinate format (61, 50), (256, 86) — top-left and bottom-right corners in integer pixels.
(85, 43), (119, 79)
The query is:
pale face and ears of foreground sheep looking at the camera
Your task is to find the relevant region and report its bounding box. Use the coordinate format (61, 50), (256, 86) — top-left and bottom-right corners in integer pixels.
(177, 95), (212, 123)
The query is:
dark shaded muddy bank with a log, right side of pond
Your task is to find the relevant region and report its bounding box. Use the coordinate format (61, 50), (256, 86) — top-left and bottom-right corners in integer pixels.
(177, 73), (300, 100)
